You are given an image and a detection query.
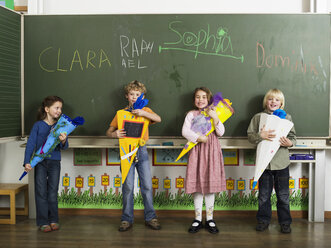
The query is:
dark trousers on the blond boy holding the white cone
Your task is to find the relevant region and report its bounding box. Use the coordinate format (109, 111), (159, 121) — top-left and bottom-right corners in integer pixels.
(256, 167), (292, 224)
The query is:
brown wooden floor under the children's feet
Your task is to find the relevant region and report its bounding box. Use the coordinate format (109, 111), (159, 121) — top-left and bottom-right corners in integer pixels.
(0, 214), (331, 248)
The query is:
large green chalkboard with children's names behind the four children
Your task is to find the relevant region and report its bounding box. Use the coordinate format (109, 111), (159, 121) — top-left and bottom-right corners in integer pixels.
(24, 14), (330, 137)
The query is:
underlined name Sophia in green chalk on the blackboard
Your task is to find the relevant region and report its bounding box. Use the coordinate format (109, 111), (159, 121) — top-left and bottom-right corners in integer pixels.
(159, 21), (244, 63)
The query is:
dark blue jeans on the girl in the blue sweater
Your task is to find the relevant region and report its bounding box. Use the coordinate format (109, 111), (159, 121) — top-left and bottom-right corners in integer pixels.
(35, 159), (61, 226)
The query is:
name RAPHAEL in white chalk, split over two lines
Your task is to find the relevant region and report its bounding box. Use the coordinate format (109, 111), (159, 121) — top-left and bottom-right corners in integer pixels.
(120, 35), (154, 69)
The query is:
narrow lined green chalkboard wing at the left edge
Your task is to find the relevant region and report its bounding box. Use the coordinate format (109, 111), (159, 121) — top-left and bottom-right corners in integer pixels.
(0, 7), (21, 138)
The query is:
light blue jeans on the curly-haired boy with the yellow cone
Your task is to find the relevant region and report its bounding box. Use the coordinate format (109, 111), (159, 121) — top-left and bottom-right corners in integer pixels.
(121, 146), (156, 223)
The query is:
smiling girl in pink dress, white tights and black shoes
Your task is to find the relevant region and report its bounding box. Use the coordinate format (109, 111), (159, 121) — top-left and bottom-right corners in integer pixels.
(182, 87), (226, 234)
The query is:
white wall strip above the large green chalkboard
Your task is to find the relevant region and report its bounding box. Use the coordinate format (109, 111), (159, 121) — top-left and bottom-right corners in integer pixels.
(29, 0), (309, 14)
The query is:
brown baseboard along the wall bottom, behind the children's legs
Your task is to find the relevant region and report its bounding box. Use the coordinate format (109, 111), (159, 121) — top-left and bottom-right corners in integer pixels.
(59, 208), (310, 218)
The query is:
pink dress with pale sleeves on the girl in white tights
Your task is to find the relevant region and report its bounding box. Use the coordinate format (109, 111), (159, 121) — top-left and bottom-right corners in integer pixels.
(182, 110), (226, 194)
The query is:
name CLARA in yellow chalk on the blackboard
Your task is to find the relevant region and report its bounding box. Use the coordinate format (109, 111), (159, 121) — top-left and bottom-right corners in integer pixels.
(39, 47), (111, 72)
